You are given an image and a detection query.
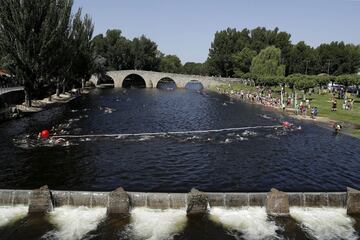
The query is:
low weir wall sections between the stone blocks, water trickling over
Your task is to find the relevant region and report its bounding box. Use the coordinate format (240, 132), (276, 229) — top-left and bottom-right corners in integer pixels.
(0, 188), (360, 214)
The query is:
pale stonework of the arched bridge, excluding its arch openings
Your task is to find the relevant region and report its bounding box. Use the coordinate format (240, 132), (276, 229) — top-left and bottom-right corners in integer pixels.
(90, 70), (242, 89)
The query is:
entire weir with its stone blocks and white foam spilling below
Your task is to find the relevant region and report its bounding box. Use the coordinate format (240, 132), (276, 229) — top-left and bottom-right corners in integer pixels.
(0, 186), (359, 240)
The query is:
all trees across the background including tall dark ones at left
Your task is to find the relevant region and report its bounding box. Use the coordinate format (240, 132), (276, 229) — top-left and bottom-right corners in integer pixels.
(0, 0), (360, 106)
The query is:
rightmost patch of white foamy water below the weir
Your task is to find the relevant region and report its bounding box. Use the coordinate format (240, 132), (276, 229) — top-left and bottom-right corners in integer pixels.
(290, 207), (359, 240)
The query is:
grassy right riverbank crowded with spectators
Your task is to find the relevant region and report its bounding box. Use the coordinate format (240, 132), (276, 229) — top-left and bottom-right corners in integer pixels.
(213, 83), (360, 138)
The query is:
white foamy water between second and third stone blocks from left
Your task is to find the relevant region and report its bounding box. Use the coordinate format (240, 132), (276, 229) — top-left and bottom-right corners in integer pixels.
(131, 208), (187, 240)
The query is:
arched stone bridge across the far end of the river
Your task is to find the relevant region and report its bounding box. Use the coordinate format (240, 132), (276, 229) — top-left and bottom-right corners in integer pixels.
(90, 70), (242, 89)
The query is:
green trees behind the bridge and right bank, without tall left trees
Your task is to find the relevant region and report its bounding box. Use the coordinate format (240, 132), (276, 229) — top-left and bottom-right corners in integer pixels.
(93, 27), (360, 77)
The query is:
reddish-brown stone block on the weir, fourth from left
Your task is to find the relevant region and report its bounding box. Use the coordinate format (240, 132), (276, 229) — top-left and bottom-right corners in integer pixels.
(266, 188), (290, 216)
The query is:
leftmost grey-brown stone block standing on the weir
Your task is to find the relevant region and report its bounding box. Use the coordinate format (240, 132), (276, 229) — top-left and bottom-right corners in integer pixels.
(29, 186), (54, 214)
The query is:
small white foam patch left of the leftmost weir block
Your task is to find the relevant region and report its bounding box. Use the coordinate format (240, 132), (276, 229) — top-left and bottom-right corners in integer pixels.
(0, 205), (28, 227)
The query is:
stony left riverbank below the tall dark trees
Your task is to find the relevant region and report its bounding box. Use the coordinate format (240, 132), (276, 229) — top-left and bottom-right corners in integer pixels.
(0, 89), (90, 122)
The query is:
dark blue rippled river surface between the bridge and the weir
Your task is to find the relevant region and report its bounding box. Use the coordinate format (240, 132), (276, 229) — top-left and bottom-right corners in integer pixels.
(0, 89), (360, 192)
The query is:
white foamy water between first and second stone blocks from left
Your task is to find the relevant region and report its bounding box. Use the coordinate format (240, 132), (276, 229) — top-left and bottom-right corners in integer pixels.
(50, 206), (106, 240)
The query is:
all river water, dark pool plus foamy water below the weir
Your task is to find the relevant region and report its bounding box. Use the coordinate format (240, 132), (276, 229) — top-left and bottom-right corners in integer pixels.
(0, 89), (360, 240)
